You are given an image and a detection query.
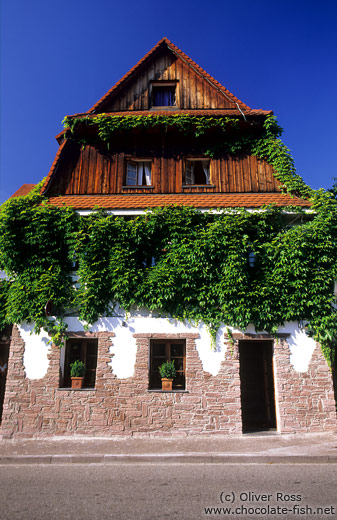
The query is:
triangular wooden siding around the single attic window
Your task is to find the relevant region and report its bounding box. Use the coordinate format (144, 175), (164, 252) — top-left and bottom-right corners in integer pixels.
(104, 52), (236, 112)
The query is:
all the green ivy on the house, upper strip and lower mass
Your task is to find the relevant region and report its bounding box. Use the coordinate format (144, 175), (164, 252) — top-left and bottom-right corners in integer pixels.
(0, 114), (337, 362)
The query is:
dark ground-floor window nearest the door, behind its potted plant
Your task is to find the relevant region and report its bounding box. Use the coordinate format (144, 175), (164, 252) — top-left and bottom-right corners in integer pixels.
(149, 339), (186, 390)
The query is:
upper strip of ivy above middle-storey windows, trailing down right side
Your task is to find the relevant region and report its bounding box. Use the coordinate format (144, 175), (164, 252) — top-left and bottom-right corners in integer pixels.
(63, 113), (314, 198)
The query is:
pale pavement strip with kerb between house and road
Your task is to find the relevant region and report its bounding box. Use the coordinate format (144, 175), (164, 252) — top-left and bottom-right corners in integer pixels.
(0, 432), (337, 465)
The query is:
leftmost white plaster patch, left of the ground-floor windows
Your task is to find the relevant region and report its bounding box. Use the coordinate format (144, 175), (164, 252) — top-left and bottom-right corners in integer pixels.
(19, 323), (51, 379)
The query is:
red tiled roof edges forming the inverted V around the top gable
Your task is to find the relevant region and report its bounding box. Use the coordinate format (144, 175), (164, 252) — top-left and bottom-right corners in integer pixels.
(88, 37), (250, 112)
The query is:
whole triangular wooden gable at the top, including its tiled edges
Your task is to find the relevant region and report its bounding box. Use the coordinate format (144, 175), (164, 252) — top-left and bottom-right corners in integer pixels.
(89, 38), (249, 113)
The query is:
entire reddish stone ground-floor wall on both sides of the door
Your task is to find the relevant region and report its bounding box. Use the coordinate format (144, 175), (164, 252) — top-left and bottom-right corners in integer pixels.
(0, 327), (337, 437)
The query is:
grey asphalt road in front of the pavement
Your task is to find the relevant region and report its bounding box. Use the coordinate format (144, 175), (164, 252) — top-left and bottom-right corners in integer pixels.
(0, 464), (337, 520)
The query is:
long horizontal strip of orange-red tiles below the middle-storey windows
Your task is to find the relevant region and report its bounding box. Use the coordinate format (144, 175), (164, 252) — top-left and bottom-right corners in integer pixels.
(49, 193), (310, 210)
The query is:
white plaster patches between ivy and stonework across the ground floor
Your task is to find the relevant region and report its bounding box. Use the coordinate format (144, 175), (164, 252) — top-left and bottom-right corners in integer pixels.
(19, 309), (316, 379)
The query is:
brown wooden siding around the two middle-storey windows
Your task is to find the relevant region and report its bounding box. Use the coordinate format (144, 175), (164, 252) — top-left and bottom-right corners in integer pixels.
(47, 144), (280, 196)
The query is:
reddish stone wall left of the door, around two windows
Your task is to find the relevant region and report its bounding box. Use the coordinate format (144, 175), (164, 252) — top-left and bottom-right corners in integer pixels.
(1, 327), (241, 436)
